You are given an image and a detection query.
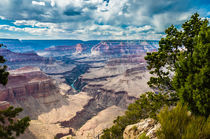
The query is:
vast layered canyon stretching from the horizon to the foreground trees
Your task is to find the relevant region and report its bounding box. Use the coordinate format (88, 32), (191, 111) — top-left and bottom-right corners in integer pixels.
(0, 40), (158, 139)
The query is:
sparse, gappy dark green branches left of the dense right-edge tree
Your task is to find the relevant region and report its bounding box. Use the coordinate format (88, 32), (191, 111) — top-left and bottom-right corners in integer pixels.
(145, 13), (208, 92)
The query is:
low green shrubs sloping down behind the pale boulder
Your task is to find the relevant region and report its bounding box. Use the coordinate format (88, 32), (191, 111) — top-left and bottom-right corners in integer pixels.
(101, 92), (174, 139)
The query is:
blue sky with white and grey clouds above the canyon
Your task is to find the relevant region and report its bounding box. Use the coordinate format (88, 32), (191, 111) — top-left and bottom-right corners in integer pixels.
(0, 0), (210, 40)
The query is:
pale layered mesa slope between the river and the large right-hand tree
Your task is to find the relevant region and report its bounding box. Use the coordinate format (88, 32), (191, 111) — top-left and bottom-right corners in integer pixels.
(77, 64), (152, 98)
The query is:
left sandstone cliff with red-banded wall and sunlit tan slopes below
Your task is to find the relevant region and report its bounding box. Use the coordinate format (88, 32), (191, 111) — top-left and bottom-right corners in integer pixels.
(0, 67), (94, 139)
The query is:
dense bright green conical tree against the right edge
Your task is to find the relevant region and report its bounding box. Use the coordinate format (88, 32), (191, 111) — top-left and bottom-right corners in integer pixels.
(173, 24), (210, 117)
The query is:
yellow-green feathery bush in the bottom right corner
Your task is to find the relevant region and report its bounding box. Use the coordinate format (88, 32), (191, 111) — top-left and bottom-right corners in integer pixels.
(158, 103), (210, 139)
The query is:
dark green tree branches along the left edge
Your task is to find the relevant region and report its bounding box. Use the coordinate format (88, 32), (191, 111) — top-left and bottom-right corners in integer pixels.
(0, 44), (30, 139)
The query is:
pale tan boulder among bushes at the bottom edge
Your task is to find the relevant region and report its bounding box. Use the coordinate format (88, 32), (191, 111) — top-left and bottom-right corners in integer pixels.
(123, 118), (160, 139)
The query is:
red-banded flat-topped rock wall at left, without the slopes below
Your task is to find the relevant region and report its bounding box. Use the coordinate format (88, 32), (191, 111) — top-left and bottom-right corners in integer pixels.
(0, 67), (57, 102)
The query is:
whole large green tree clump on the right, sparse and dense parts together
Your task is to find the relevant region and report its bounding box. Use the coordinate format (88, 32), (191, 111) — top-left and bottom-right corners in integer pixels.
(145, 13), (210, 116)
